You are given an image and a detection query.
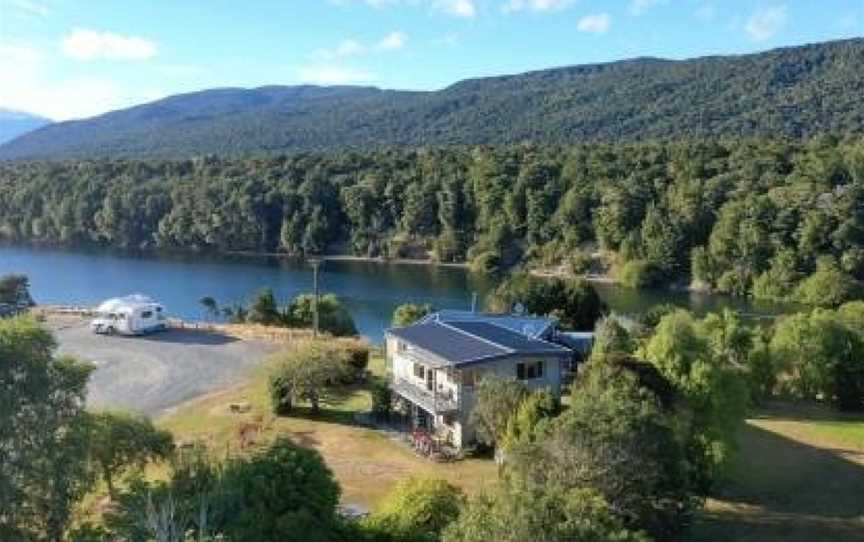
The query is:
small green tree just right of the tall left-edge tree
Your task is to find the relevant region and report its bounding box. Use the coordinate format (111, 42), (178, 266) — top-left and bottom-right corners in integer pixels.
(90, 412), (174, 498)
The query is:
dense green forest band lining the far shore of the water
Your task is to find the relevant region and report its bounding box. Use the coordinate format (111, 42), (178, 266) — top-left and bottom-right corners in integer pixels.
(0, 136), (864, 305)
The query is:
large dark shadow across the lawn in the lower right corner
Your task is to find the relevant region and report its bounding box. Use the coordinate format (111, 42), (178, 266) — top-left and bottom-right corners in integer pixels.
(692, 422), (864, 542)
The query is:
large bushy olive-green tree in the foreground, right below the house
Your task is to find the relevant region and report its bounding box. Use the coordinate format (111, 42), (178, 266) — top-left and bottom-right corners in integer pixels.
(505, 360), (701, 540)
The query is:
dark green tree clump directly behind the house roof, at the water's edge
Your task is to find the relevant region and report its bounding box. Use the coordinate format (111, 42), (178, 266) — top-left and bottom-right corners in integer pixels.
(489, 274), (606, 329)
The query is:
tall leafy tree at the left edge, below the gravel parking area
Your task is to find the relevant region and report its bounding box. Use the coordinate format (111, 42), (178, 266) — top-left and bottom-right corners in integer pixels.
(0, 317), (93, 542)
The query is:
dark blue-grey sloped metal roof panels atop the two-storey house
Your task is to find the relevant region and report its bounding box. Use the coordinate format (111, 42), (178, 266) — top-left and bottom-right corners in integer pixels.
(388, 319), (570, 365)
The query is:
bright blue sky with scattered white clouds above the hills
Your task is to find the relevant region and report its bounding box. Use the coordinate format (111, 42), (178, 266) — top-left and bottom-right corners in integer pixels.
(0, 0), (864, 120)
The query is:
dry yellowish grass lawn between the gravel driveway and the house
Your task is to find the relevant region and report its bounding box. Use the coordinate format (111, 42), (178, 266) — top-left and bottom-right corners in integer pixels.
(152, 357), (496, 506)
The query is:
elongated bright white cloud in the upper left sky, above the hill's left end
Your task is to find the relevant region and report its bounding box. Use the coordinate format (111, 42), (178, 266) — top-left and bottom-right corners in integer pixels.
(60, 28), (156, 60)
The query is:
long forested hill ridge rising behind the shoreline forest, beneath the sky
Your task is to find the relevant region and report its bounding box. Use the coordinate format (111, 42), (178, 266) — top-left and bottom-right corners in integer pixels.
(0, 38), (864, 159)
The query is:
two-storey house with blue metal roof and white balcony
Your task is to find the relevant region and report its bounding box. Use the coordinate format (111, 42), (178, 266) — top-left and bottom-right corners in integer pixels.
(385, 311), (574, 449)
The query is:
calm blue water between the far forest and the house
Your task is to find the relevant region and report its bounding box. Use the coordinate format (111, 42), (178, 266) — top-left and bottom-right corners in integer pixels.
(0, 246), (783, 341)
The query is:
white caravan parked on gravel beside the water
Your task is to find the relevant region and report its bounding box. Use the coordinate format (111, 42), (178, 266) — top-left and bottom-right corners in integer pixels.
(90, 294), (167, 335)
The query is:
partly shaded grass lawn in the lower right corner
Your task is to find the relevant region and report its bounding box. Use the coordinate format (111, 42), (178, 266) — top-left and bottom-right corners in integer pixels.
(692, 404), (864, 542)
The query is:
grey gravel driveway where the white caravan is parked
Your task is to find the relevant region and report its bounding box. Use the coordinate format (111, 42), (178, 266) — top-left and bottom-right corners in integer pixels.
(49, 319), (277, 416)
